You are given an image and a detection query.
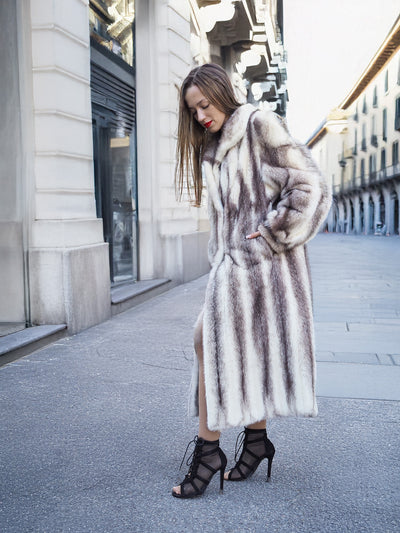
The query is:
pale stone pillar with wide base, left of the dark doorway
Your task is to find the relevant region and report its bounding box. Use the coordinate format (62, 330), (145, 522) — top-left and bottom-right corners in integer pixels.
(24, 0), (111, 333)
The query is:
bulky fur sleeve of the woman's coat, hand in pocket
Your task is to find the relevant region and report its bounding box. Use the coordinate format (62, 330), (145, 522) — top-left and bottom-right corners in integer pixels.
(253, 112), (332, 253)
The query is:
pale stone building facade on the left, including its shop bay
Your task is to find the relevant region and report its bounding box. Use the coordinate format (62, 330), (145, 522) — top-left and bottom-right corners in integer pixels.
(0, 0), (287, 334)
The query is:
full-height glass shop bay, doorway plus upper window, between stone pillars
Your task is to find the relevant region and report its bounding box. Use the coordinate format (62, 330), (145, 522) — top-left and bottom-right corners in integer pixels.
(90, 0), (138, 283)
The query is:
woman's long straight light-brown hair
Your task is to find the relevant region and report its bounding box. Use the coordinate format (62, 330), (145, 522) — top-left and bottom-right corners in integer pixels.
(175, 63), (240, 207)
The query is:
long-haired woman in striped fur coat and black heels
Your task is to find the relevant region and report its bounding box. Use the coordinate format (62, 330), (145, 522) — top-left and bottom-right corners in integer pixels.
(172, 64), (331, 498)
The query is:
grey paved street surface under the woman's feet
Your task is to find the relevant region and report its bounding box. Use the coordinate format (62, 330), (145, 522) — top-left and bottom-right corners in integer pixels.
(0, 235), (400, 533)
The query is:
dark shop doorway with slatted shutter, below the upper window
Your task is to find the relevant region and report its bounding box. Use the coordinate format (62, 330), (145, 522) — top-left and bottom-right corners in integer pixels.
(91, 40), (138, 284)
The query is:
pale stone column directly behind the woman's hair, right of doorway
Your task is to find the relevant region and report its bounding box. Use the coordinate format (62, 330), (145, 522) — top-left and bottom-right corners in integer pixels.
(135, 0), (209, 282)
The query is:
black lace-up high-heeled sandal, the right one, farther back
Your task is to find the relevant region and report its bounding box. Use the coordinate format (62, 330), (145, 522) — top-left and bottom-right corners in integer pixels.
(227, 428), (275, 481)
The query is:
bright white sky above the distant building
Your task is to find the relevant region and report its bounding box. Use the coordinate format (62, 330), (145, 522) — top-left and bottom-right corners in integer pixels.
(284, 0), (400, 142)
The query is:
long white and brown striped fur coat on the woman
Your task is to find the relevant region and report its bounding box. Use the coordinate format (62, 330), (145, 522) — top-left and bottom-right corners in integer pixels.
(190, 104), (331, 430)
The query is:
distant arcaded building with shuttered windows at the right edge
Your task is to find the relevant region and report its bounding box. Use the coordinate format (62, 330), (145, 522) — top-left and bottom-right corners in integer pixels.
(308, 17), (400, 235)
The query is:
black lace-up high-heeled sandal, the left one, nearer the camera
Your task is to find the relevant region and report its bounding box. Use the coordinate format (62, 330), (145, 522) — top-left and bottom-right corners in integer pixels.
(172, 435), (227, 498)
